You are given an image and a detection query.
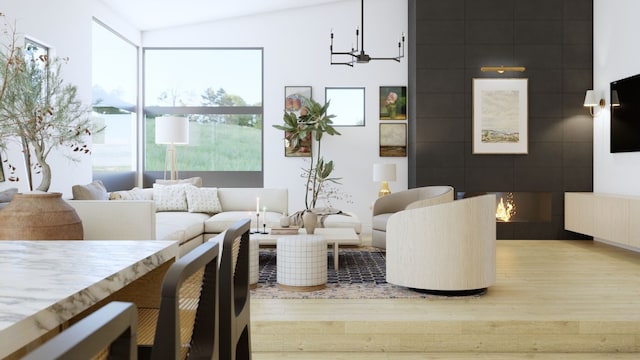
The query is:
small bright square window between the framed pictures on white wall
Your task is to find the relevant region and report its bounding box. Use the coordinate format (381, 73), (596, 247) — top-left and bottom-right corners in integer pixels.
(324, 87), (364, 126)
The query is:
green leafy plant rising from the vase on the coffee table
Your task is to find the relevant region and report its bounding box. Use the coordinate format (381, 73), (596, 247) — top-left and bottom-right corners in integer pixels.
(273, 98), (340, 232)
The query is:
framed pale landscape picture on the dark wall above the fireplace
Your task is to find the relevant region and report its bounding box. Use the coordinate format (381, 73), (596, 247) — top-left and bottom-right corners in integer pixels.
(473, 79), (528, 154)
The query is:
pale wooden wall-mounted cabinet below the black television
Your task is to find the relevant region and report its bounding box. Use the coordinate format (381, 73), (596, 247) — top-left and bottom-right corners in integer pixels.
(564, 192), (640, 251)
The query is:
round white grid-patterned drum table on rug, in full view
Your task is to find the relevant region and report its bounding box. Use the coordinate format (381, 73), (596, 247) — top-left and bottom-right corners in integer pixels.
(276, 234), (327, 291)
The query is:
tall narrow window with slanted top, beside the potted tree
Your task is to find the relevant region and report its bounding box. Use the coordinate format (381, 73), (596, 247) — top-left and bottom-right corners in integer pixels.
(92, 20), (138, 172)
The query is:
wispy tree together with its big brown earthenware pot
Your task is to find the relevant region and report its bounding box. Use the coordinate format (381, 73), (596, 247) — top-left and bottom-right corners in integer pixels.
(0, 18), (93, 239)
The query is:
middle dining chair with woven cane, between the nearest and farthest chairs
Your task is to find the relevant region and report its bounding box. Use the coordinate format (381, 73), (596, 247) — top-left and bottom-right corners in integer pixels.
(138, 241), (220, 360)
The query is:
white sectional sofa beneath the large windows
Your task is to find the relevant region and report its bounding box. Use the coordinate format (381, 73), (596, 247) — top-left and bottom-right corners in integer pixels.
(67, 188), (361, 255)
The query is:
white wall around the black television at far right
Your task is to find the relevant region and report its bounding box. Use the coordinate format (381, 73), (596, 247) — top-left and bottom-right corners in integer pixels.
(593, 0), (640, 195)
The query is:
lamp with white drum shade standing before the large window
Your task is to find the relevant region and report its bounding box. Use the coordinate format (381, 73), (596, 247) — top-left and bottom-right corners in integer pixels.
(156, 116), (189, 181)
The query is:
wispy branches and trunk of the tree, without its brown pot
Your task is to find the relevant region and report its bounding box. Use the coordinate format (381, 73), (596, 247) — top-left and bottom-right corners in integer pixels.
(0, 17), (93, 192)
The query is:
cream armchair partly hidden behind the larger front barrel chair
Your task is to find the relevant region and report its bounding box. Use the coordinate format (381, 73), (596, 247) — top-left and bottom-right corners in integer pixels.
(371, 186), (453, 248)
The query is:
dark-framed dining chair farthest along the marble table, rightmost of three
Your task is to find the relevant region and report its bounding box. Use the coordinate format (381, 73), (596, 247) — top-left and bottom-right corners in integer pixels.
(220, 219), (251, 360)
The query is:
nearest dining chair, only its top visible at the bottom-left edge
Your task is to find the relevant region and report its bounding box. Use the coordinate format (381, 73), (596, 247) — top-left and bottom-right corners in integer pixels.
(23, 301), (138, 360)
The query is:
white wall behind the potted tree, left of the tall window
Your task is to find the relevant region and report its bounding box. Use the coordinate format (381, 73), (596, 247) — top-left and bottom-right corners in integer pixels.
(0, 0), (91, 197)
